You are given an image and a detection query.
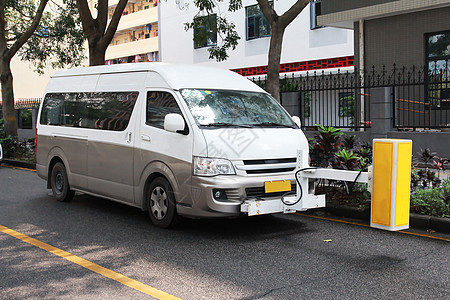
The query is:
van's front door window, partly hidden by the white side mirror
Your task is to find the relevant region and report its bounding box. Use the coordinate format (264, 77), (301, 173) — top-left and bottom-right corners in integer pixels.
(146, 91), (182, 128)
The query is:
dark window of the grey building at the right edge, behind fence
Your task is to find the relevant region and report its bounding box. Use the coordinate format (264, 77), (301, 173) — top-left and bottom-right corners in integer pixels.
(425, 31), (450, 109)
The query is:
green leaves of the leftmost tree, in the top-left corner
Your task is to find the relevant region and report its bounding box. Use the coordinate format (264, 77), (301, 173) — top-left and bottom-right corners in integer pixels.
(5, 0), (85, 74)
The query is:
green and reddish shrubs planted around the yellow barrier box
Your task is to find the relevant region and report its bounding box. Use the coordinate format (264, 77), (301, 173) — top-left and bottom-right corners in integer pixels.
(309, 124), (450, 217)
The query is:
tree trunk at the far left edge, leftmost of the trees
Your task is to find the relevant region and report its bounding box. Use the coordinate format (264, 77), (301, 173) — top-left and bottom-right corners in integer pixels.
(0, 59), (17, 136)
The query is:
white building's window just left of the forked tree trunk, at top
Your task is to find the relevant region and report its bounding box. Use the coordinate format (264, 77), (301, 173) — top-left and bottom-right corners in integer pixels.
(245, 1), (273, 41)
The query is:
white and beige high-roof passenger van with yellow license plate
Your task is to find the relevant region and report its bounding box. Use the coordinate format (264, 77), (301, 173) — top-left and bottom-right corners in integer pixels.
(36, 63), (308, 227)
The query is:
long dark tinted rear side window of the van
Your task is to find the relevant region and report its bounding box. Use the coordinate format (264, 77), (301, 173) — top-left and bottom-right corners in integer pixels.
(40, 92), (139, 131)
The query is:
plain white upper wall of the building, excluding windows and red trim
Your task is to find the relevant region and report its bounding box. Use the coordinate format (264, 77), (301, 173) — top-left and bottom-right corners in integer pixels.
(158, 0), (353, 69)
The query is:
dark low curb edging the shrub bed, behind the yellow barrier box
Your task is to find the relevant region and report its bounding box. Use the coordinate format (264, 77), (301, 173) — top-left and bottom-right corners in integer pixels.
(323, 204), (450, 233)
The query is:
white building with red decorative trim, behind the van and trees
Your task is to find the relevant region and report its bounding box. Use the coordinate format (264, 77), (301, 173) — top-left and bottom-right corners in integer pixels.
(159, 0), (354, 76)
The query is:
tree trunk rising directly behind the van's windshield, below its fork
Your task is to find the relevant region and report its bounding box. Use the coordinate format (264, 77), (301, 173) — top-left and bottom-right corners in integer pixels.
(266, 23), (285, 102)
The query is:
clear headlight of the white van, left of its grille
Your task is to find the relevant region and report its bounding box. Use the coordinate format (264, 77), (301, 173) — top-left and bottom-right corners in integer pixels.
(194, 156), (236, 176)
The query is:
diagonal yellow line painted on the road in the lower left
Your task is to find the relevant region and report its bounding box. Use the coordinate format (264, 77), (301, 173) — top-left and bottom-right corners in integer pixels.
(0, 225), (180, 300)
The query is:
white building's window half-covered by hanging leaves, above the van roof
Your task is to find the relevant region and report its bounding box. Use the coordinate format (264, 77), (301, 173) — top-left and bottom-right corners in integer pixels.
(194, 14), (217, 49)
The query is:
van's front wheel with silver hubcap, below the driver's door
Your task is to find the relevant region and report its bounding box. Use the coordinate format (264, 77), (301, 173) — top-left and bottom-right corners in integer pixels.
(146, 177), (178, 228)
